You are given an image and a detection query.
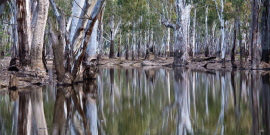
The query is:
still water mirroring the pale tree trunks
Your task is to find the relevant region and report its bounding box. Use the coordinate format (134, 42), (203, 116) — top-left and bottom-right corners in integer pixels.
(0, 68), (270, 135)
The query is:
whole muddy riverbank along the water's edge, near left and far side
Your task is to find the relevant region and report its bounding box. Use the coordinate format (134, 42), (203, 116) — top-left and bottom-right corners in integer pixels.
(0, 57), (270, 89)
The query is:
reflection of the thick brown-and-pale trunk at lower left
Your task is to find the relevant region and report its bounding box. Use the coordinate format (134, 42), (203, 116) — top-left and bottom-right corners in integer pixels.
(17, 87), (48, 135)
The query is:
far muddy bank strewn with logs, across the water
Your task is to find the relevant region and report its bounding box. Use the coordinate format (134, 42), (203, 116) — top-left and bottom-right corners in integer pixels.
(98, 57), (270, 71)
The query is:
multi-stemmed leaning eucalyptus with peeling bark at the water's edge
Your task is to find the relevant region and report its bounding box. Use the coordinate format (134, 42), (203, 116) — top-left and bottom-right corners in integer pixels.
(50, 0), (105, 83)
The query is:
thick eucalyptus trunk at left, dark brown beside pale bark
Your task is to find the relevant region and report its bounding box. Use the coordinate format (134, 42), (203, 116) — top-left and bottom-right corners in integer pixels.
(16, 0), (49, 74)
